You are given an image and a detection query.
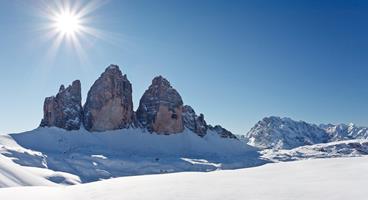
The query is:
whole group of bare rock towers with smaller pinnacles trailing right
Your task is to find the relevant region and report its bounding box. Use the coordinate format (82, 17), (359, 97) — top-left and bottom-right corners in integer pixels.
(40, 65), (236, 138)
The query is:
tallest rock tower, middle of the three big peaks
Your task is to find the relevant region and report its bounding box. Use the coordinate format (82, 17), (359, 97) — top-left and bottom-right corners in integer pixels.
(84, 65), (134, 131)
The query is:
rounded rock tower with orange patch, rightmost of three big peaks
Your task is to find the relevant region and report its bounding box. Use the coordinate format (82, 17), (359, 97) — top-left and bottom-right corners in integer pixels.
(136, 76), (184, 134)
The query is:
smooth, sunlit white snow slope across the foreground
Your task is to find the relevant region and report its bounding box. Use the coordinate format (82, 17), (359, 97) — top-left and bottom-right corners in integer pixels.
(0, 157), (368, 200)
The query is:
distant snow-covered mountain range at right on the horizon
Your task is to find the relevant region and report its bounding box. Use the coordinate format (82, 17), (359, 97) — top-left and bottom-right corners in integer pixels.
(246, 116), (368, 149)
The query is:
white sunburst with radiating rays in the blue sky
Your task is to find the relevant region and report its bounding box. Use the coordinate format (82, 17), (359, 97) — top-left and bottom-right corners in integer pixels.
(36, 0), (106, 61)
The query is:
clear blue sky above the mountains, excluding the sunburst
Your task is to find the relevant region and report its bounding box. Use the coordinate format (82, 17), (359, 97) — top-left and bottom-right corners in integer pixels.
(0, 0), (368, 134)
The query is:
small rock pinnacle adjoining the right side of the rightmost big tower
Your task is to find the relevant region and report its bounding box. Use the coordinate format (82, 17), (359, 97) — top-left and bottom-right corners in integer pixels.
(183, 105), (208, 137)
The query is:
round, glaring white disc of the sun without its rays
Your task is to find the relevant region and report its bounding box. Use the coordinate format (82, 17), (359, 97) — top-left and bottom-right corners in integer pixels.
(55, 12), (81, 34)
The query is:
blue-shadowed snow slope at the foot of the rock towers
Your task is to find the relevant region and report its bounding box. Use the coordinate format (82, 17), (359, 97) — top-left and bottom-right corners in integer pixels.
(0, 127), (266, 187)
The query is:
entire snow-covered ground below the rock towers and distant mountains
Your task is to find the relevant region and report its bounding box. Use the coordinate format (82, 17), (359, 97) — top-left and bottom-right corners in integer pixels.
(0, 128), (368, 200)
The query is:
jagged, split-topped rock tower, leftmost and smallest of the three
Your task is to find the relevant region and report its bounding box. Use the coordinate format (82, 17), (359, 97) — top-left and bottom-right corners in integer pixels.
(40, 80), (82, 130)
